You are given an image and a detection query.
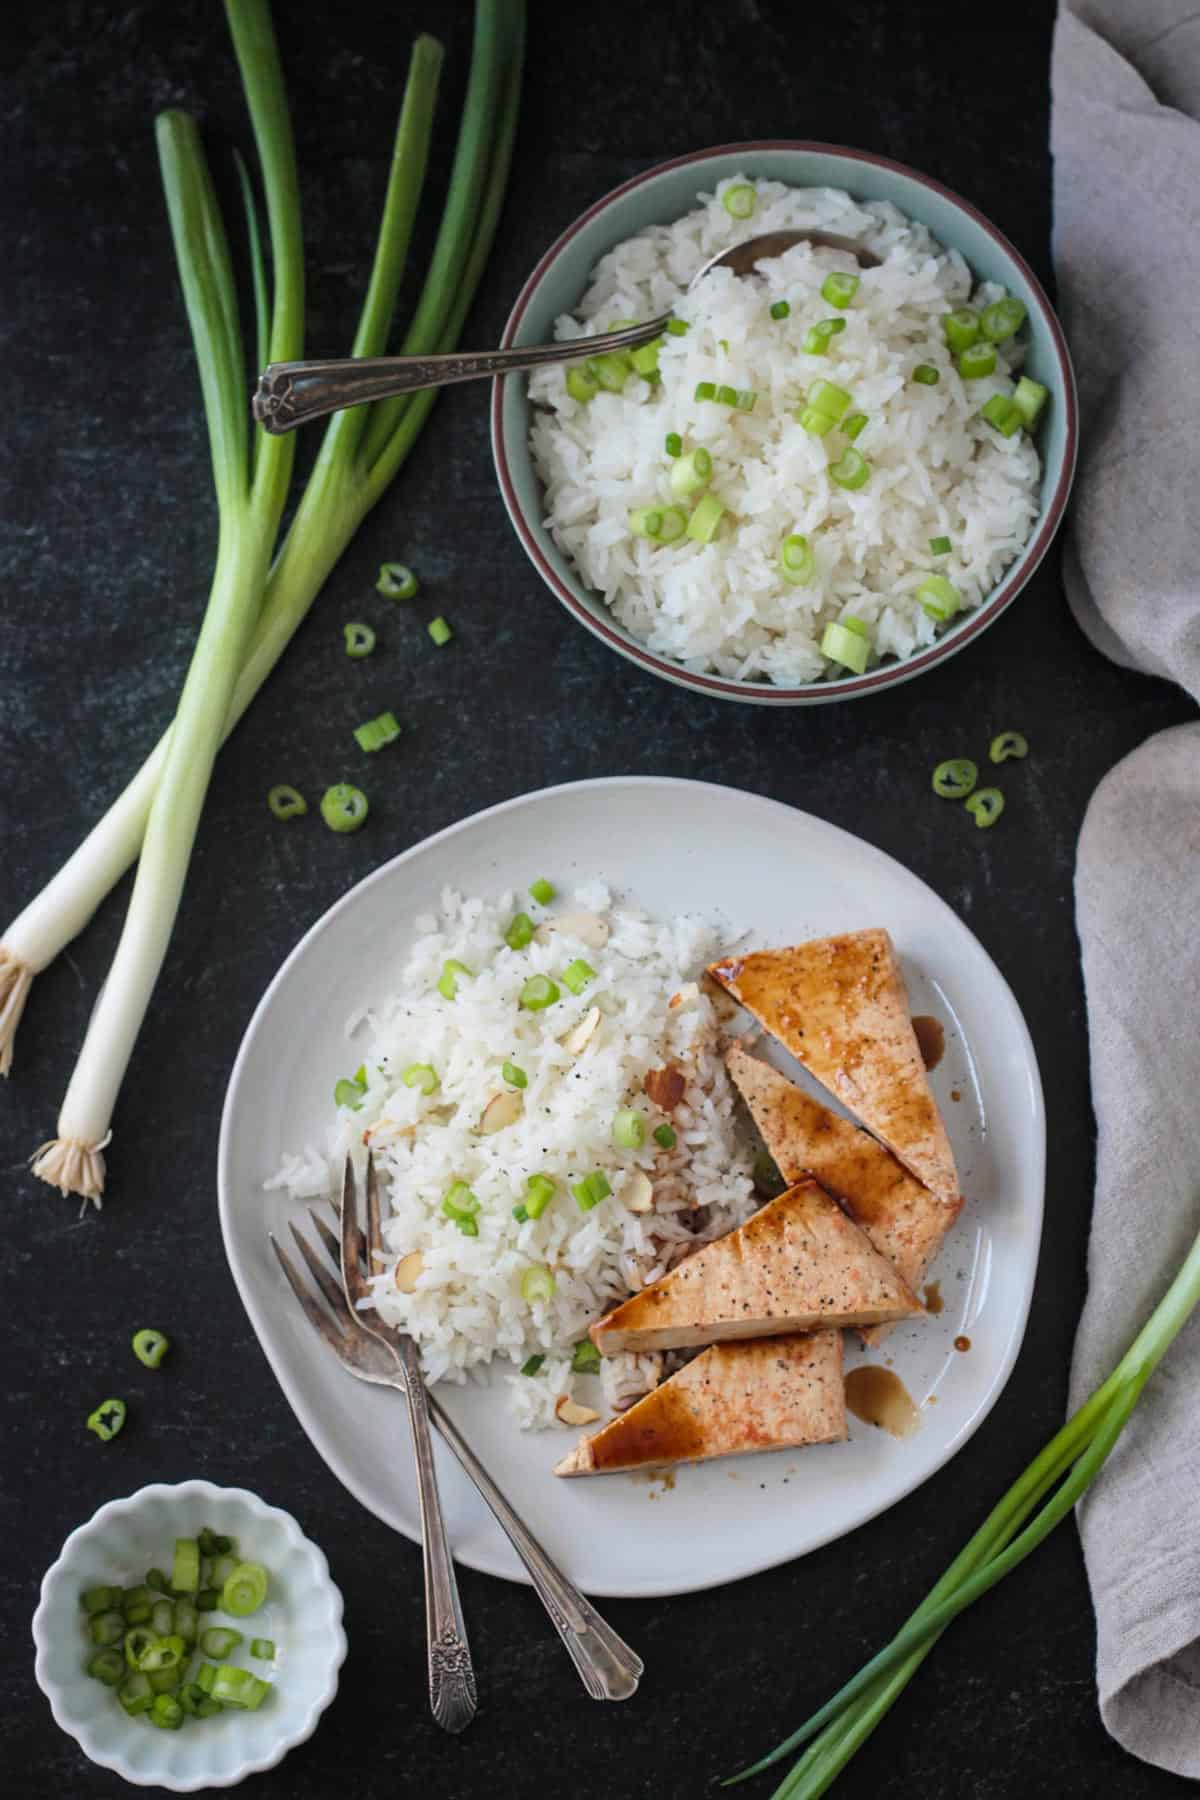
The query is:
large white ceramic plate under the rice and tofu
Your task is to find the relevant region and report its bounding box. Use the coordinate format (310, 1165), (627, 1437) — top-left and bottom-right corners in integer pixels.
(219, 778), (1045, 1595)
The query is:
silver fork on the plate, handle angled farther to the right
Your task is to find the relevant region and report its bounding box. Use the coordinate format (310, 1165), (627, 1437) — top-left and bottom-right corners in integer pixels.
(270, 1208), (644, 1701)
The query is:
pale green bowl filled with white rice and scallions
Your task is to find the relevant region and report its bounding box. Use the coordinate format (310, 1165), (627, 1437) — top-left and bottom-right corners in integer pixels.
(491, 142), (1078, 706)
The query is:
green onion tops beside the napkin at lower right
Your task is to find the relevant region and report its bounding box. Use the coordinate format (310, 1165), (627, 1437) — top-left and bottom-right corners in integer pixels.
(725, 1209), (1200, 1800)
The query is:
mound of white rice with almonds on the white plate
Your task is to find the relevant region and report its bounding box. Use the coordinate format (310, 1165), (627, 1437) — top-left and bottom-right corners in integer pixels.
(268, 886), (756, 1427)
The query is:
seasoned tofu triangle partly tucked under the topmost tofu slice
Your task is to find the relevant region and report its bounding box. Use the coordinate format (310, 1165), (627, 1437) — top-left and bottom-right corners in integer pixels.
(725, 1044), (963, 1343)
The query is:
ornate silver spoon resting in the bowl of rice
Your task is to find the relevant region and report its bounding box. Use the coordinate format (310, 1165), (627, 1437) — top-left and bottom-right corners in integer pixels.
(252, 230), (880, 436)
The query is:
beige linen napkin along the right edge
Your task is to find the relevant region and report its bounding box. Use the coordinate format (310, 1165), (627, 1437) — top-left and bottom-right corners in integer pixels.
(1051, 0), (1200, 1778)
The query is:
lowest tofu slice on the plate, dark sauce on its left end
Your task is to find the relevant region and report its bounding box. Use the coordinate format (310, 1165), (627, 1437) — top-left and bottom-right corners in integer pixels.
(554, 1332), (846, 1476)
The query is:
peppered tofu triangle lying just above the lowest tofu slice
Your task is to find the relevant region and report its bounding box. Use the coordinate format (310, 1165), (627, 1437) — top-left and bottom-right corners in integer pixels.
(592, 1181), (923, 1355)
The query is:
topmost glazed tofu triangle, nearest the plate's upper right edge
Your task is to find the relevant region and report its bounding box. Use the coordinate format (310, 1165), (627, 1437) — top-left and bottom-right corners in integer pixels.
(709, 931), (959, 1206)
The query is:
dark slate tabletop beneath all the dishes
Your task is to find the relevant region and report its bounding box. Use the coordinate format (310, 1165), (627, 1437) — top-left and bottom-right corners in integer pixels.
(0, 0), (1189, 1800)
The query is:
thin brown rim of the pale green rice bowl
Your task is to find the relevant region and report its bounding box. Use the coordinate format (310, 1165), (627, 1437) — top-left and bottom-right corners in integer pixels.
(491, 137), (1079, 706)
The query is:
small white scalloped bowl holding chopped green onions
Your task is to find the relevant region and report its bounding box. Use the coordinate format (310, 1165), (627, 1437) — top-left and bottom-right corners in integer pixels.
(34, 1481), (345, 1793)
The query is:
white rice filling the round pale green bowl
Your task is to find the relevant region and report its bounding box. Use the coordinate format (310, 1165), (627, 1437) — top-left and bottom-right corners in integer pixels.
(529, 176), (1040, 684)
